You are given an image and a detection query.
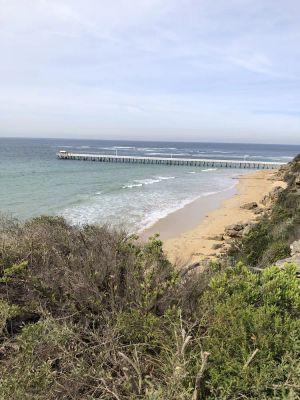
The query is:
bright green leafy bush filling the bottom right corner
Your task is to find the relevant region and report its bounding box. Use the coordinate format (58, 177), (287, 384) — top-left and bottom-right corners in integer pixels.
(199, 265), (300, 399)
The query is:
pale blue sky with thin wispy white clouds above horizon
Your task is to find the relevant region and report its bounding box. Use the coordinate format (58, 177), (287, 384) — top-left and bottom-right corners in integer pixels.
(0, 0), (300, 144)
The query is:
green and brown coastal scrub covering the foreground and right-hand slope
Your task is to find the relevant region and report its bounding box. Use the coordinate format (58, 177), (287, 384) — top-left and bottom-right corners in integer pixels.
(0, 155), (300, 400)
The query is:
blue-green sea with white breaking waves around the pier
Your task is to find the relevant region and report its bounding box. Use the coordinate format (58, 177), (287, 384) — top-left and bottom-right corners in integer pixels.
(0, 138), (300, 232)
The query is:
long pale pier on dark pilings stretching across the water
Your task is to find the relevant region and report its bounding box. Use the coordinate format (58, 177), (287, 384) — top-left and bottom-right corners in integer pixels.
(56, 151), (285, 169)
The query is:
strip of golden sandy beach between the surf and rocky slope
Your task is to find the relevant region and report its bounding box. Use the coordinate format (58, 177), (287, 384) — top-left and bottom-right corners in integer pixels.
(142, 170), (285, 265)
